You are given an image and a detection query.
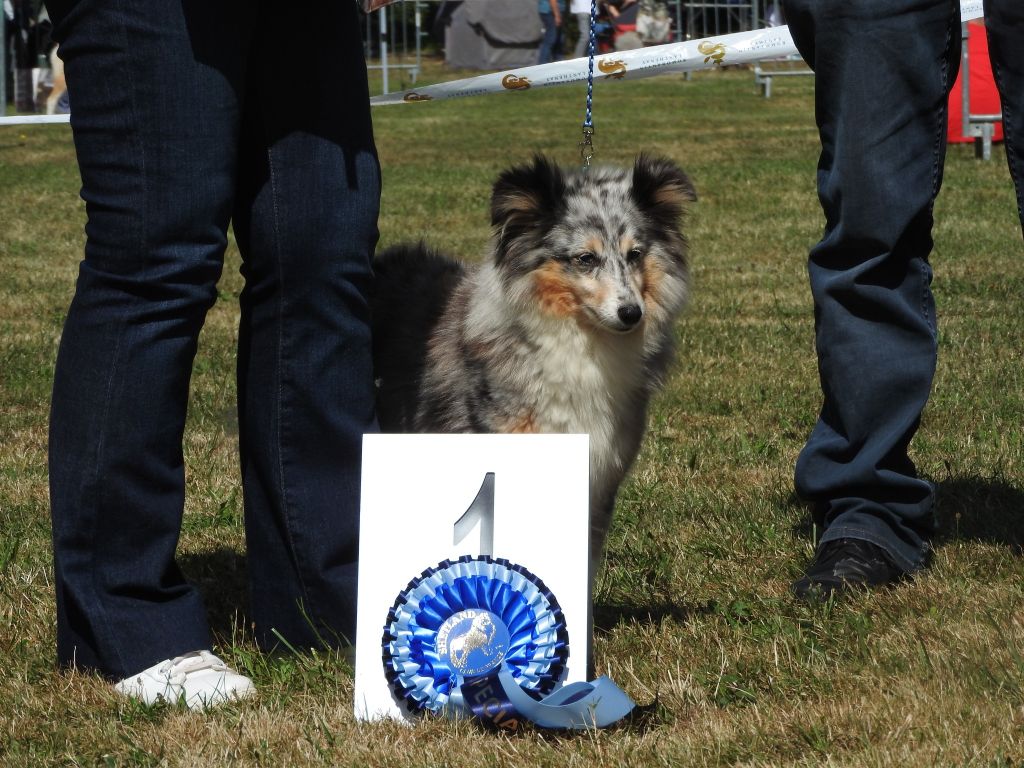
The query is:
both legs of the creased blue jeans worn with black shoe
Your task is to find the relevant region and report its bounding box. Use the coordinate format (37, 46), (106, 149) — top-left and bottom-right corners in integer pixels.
(785, 0), (1024, 571)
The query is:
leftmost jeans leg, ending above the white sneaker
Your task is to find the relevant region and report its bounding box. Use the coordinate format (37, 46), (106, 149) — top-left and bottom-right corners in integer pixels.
(49, 0), (247, 678)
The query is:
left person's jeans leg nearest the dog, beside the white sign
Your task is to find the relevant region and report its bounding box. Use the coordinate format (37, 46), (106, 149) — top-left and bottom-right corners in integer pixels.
(234, 0), (380, 647)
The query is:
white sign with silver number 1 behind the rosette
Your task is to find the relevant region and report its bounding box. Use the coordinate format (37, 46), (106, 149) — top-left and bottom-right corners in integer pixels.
(354, 434), (590, 720)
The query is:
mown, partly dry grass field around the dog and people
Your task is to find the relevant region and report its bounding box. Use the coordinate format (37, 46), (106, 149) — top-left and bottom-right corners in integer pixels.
(0, 61), (1024, 768)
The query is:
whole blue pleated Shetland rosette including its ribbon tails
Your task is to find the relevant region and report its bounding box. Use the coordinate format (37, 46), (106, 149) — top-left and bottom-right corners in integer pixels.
(382, 555), (635, 729)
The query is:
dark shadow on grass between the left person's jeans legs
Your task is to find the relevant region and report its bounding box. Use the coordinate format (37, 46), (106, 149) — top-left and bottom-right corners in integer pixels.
(178, 547), (250, 641)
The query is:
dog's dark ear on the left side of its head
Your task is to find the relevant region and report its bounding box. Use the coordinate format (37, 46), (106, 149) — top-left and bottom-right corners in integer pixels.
(490, 155), (565, 260)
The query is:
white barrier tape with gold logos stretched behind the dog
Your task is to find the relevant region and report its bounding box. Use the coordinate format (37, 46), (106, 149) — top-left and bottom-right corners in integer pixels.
(370, 0), (982, 106)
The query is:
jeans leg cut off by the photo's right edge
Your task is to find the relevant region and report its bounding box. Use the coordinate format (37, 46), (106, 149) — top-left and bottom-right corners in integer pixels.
(985, 0), (1024, 228)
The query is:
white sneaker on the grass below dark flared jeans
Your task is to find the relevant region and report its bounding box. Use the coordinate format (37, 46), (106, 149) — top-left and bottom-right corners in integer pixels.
(114, 650), (256, 710)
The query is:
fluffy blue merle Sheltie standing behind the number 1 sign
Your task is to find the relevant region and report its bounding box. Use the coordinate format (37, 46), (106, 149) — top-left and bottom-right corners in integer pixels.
(371, 155), (696, 575)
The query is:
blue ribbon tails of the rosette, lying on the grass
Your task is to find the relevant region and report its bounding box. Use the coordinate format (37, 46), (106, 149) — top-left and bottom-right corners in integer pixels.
(462, 670), (636, 730)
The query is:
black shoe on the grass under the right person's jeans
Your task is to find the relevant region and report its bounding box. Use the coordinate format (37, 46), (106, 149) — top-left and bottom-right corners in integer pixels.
(793, 539), (906, 600)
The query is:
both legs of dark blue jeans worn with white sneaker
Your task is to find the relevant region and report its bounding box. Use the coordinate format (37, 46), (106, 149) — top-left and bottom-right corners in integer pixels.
(48, 0), (380, 678)
